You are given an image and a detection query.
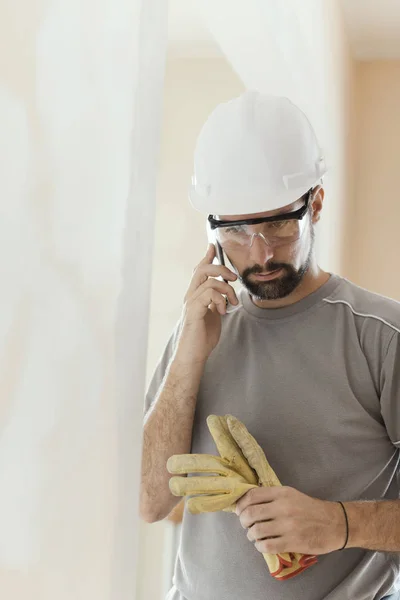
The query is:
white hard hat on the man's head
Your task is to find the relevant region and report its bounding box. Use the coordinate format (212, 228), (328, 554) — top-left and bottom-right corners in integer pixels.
(189, 91), (327, 215)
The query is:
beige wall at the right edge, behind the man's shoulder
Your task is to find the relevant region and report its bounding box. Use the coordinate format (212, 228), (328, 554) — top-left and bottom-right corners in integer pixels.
(347, 61), (400, 300)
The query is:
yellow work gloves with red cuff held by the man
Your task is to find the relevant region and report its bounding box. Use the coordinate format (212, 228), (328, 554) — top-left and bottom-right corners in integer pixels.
(167, 415), (316, 580)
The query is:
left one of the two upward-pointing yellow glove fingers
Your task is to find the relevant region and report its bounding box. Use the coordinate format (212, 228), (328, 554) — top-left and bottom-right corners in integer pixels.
(207, 415), (258, 485)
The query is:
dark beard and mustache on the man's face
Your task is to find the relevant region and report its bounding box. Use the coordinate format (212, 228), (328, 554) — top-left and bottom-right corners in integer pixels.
(240, 226), (315, 300)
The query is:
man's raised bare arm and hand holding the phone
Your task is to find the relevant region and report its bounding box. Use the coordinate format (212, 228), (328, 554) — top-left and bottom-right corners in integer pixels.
(140, 245), (238, 522)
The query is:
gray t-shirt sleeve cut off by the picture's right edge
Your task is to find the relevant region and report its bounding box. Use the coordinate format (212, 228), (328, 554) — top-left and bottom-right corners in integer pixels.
(381, 332), (400, 448)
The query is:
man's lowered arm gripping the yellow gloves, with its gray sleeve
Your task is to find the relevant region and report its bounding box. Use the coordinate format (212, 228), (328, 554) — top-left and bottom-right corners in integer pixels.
(236, 331), (400, 554)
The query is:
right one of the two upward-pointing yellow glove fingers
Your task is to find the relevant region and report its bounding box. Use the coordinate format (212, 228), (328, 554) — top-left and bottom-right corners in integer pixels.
(227, 415), (281, 487)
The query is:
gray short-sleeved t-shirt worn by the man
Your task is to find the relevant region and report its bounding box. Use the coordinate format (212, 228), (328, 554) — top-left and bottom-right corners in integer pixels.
(146, 275), (400, 600)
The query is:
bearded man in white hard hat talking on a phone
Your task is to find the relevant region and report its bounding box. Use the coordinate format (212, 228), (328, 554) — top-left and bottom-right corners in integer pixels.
(141, 92), (400, 600)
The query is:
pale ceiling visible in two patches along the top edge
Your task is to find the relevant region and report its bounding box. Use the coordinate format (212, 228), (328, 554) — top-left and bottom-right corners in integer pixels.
(169, 0), (400, 60)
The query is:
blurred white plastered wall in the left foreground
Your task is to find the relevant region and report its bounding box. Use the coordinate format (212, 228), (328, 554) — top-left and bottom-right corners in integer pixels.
(0, 0), (167, 600)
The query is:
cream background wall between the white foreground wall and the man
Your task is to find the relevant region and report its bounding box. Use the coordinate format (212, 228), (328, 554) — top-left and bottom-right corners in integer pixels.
(138, 58), (244, 600)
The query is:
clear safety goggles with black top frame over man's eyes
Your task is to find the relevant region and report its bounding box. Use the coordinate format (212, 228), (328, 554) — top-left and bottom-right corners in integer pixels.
(208, 189), (312, 252)
